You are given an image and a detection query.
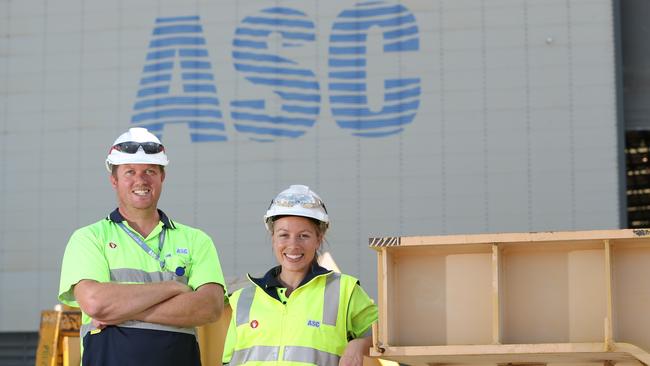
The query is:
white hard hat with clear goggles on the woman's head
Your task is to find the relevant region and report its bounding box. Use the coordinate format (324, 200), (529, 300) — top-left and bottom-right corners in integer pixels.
(264, 184), (330, 231)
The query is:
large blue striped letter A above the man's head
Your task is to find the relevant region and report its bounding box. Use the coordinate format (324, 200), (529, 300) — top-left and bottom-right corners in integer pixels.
(131, 16), (227, 142)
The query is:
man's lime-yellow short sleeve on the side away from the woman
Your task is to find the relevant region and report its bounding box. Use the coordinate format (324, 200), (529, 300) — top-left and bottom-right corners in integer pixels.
(59, 227), (111, 307)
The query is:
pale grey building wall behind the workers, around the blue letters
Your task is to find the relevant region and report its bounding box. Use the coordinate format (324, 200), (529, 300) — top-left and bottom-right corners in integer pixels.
(0, 0), (622, 331)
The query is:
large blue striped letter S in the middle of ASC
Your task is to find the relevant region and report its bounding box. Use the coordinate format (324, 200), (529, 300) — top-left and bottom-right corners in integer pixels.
(230, 7), (321, 141)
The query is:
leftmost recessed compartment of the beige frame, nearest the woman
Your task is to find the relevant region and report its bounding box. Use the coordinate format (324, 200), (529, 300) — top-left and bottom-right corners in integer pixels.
(380, 246), (492, 346)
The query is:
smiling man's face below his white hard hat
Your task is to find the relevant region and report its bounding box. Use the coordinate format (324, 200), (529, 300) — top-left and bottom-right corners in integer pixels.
(110, 164), (165, 210)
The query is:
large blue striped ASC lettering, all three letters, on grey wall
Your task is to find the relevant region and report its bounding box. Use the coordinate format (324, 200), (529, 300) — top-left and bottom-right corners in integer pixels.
(131, 1), (421, 142)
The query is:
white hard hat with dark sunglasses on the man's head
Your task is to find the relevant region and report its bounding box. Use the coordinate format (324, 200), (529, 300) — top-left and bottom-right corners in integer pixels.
(106, 127), (169, 172)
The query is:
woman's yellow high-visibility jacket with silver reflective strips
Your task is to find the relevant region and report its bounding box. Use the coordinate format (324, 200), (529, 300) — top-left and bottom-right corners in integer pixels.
(224, 267), (377, 366)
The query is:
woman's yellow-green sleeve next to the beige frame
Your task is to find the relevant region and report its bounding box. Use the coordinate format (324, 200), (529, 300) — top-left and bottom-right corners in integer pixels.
(347, 284), (379, 339)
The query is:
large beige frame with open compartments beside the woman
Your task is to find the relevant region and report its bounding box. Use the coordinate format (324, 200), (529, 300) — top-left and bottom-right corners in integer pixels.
(370, 230), (650, 365)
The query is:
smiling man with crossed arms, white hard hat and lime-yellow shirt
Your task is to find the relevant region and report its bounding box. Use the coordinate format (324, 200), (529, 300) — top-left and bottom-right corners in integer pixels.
(59, 128), (225, 366)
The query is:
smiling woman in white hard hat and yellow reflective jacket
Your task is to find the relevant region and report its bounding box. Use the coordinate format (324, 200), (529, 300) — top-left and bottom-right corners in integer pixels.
(224, 185), (377, 366)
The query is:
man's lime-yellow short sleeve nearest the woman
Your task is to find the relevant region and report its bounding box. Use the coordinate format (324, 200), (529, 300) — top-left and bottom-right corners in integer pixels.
(188, 230), (227, 293)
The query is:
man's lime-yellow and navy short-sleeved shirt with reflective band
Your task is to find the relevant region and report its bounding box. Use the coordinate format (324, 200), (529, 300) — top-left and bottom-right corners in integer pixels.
(59, 209), (225, 365)
